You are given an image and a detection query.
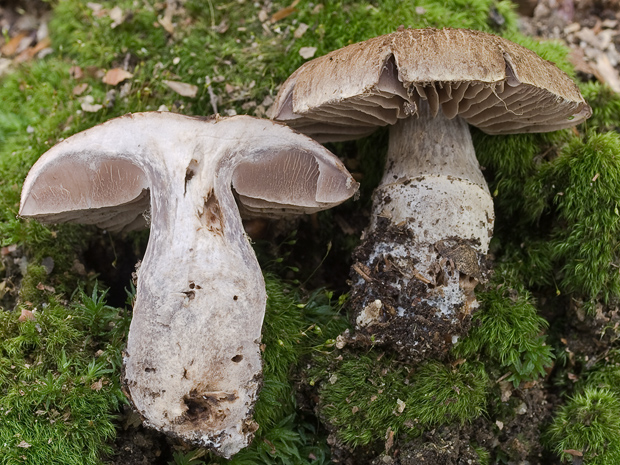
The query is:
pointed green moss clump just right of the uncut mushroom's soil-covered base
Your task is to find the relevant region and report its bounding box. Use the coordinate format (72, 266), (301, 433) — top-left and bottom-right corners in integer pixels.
(453, 269), (553, 387)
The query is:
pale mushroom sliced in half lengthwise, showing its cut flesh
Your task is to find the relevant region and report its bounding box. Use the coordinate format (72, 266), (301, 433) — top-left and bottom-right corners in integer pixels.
(19, 112), (357, 457)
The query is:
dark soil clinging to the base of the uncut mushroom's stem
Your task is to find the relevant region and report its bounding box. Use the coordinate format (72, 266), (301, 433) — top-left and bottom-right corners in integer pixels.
(349, 214), (487, 363)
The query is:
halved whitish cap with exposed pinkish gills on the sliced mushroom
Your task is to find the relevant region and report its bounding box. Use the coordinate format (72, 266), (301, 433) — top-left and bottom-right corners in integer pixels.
(19, 112), (358, 231)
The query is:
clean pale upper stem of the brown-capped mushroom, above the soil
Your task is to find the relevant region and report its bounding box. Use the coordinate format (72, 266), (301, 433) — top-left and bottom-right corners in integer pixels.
(371, 102), (494, 246)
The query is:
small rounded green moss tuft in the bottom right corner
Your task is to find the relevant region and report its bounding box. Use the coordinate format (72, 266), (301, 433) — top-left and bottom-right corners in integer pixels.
(547, 388), (620, 465)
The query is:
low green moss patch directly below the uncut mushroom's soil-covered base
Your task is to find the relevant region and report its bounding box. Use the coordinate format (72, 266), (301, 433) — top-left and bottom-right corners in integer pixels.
(311, 352), (488, 447)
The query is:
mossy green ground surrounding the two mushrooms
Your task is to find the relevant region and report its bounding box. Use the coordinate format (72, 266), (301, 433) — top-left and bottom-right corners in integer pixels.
(0, 0), (620, 465)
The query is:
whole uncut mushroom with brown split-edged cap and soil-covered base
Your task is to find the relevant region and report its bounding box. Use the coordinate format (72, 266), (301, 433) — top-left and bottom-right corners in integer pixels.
(272, 29), (591, 359)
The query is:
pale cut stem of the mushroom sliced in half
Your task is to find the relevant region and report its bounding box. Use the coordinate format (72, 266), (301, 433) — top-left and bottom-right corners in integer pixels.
(124, 154), (266, 457)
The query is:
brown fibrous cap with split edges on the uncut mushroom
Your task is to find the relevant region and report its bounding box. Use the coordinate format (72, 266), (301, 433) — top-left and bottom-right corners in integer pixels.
(272, 29), (592, 142)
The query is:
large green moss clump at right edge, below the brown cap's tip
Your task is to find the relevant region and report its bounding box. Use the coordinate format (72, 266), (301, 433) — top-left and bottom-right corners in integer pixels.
(527, 132), (620, 302)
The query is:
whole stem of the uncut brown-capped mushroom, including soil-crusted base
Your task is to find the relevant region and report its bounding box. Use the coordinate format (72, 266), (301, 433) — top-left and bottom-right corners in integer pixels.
(352, 101), (494, 359)
